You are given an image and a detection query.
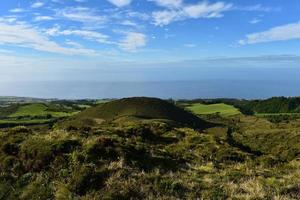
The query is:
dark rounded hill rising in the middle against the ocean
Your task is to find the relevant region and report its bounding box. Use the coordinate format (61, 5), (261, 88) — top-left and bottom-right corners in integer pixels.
(75, 97), (207, 127)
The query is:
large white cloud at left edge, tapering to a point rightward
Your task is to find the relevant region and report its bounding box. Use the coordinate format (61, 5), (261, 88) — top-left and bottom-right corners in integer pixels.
(0, 20), (97, 55)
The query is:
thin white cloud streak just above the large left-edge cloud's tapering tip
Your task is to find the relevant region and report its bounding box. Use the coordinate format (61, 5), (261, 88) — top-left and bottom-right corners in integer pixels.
(46, 27), (110, 43)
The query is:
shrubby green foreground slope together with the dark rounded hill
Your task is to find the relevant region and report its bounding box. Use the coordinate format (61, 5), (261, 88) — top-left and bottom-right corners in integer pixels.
(0, 98), (300, 200)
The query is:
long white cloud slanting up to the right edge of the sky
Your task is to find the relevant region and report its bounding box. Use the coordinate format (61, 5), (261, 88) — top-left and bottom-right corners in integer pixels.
(239, 22), (300, 45)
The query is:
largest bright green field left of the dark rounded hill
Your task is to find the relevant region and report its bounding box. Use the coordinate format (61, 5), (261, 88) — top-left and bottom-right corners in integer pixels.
(9, 104), (72, 117)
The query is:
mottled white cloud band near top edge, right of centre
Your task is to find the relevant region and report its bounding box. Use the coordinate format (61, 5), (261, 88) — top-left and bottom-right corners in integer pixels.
(152, 1), (233, 26)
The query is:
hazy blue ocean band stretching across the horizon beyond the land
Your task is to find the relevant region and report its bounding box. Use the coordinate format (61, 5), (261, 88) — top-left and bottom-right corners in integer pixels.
(0, 80), (300, 99)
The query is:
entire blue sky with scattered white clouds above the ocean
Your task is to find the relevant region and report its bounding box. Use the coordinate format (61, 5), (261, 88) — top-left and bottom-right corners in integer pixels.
(0, 0), (300, 81)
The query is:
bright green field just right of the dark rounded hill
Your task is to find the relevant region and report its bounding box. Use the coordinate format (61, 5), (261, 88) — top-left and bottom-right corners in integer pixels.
(187, 103), (241, 116)
